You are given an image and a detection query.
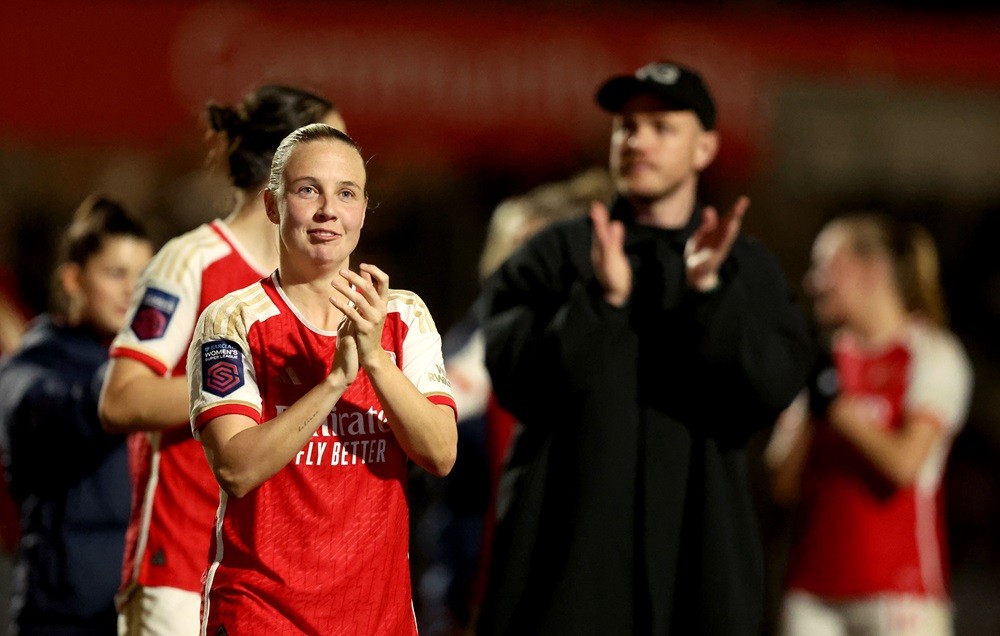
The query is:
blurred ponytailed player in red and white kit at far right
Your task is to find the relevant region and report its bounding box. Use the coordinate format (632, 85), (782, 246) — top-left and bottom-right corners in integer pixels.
(768, 215), (972, 636)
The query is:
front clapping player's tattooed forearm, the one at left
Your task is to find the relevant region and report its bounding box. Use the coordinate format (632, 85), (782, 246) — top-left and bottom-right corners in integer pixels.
(202, 378), (347, 497)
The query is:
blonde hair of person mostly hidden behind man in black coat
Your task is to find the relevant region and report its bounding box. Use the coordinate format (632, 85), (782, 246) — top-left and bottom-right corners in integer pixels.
(479, 168), (614, 279)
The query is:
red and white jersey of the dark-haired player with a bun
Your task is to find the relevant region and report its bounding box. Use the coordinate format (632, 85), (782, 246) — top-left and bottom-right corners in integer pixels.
(111, 221), (269, 606)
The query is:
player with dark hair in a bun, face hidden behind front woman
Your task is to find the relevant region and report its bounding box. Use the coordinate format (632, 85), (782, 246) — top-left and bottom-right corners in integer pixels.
(100, 85), (344, 636)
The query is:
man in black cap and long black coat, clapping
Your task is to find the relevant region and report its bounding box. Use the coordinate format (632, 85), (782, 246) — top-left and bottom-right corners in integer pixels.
(478, 62), (810, 636)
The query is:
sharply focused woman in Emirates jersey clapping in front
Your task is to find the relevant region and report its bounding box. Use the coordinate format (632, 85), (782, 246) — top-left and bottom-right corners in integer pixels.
(188, 124), (457, 635)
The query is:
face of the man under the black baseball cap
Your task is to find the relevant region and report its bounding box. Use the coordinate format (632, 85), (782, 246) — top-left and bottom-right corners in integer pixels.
(610, 95), (718, 202)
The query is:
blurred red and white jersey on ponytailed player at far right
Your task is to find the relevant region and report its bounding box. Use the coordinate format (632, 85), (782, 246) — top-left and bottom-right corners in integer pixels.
(789, 322), (972, 599)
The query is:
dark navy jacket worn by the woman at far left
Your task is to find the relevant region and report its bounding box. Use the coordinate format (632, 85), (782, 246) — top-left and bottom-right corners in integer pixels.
(0, 317), (131, 635)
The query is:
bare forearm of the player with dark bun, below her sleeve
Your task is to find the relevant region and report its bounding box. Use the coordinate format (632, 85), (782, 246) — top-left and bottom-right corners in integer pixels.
(98, 362), (189, 433)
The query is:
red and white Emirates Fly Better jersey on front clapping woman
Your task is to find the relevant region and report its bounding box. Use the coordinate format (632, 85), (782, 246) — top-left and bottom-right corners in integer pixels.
(188, 275), (455, 634)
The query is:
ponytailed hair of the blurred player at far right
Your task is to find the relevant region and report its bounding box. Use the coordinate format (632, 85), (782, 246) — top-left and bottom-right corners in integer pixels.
(829, 213), (948, 327)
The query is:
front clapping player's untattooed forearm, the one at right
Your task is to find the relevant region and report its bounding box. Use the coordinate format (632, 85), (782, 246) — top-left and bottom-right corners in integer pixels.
(366, 364), (458, 477)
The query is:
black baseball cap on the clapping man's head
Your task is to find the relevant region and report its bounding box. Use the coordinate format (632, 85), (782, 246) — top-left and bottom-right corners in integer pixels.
(595, 62), (715, 130)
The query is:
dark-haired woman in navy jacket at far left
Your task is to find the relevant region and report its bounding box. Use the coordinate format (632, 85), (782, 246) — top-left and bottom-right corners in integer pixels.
(0, 196), (153, 636)
